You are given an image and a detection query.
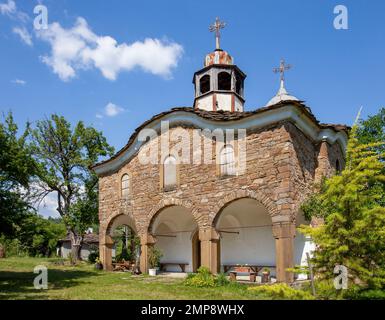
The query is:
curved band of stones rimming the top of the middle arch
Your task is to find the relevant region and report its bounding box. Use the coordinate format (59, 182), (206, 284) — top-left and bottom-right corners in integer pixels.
(143, 198), (203, 234)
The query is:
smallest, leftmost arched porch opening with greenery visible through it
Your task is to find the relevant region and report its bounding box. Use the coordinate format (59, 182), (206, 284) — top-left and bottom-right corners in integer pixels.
(100, 214), (140, 271)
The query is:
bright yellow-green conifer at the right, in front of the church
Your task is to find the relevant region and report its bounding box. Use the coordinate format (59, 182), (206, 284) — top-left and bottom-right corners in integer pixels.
(300, 114), (385, 289)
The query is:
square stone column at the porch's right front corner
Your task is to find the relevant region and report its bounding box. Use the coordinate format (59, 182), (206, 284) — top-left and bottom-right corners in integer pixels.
(273, 219), (295, 283)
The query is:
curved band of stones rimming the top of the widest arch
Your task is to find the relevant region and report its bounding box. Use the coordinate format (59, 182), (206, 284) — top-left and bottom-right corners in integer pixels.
(209, 189), (278, 227)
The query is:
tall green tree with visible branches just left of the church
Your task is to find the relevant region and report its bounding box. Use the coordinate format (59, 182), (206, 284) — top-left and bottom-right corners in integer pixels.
(30, 115), (114, 260)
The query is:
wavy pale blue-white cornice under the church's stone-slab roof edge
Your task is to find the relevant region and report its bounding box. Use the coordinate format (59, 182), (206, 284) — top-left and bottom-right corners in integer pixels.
(92, 101), (348, 176)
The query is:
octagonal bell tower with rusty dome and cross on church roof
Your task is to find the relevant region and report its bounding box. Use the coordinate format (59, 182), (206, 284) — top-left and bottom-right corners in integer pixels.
(193, 18), (246, 112)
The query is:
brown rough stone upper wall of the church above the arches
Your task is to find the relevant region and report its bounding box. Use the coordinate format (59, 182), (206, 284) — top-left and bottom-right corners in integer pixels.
(99, 122), (344, 234)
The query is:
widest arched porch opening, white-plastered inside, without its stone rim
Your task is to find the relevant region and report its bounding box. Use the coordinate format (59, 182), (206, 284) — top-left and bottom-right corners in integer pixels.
(214, 198), (276, 275)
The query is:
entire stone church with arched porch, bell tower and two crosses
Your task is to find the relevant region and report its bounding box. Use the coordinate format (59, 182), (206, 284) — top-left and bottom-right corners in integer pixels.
(93, 21), (348, 282)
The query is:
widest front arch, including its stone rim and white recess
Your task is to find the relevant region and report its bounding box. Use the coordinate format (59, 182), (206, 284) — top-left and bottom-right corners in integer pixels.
(210, 189), (278, 277)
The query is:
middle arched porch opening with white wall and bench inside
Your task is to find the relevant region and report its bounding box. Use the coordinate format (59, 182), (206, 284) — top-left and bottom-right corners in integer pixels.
(149, 205), (199, 272)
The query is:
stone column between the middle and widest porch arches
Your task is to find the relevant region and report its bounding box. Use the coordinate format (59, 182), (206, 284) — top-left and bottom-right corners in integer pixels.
(199, 227), (219, 274)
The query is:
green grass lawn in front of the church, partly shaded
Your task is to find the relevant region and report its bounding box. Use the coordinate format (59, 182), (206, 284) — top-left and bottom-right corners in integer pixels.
(0, 257), (258, 300)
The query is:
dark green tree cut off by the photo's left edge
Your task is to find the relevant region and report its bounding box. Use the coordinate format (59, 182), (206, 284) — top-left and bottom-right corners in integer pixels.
(0, 113), (35, 237)
